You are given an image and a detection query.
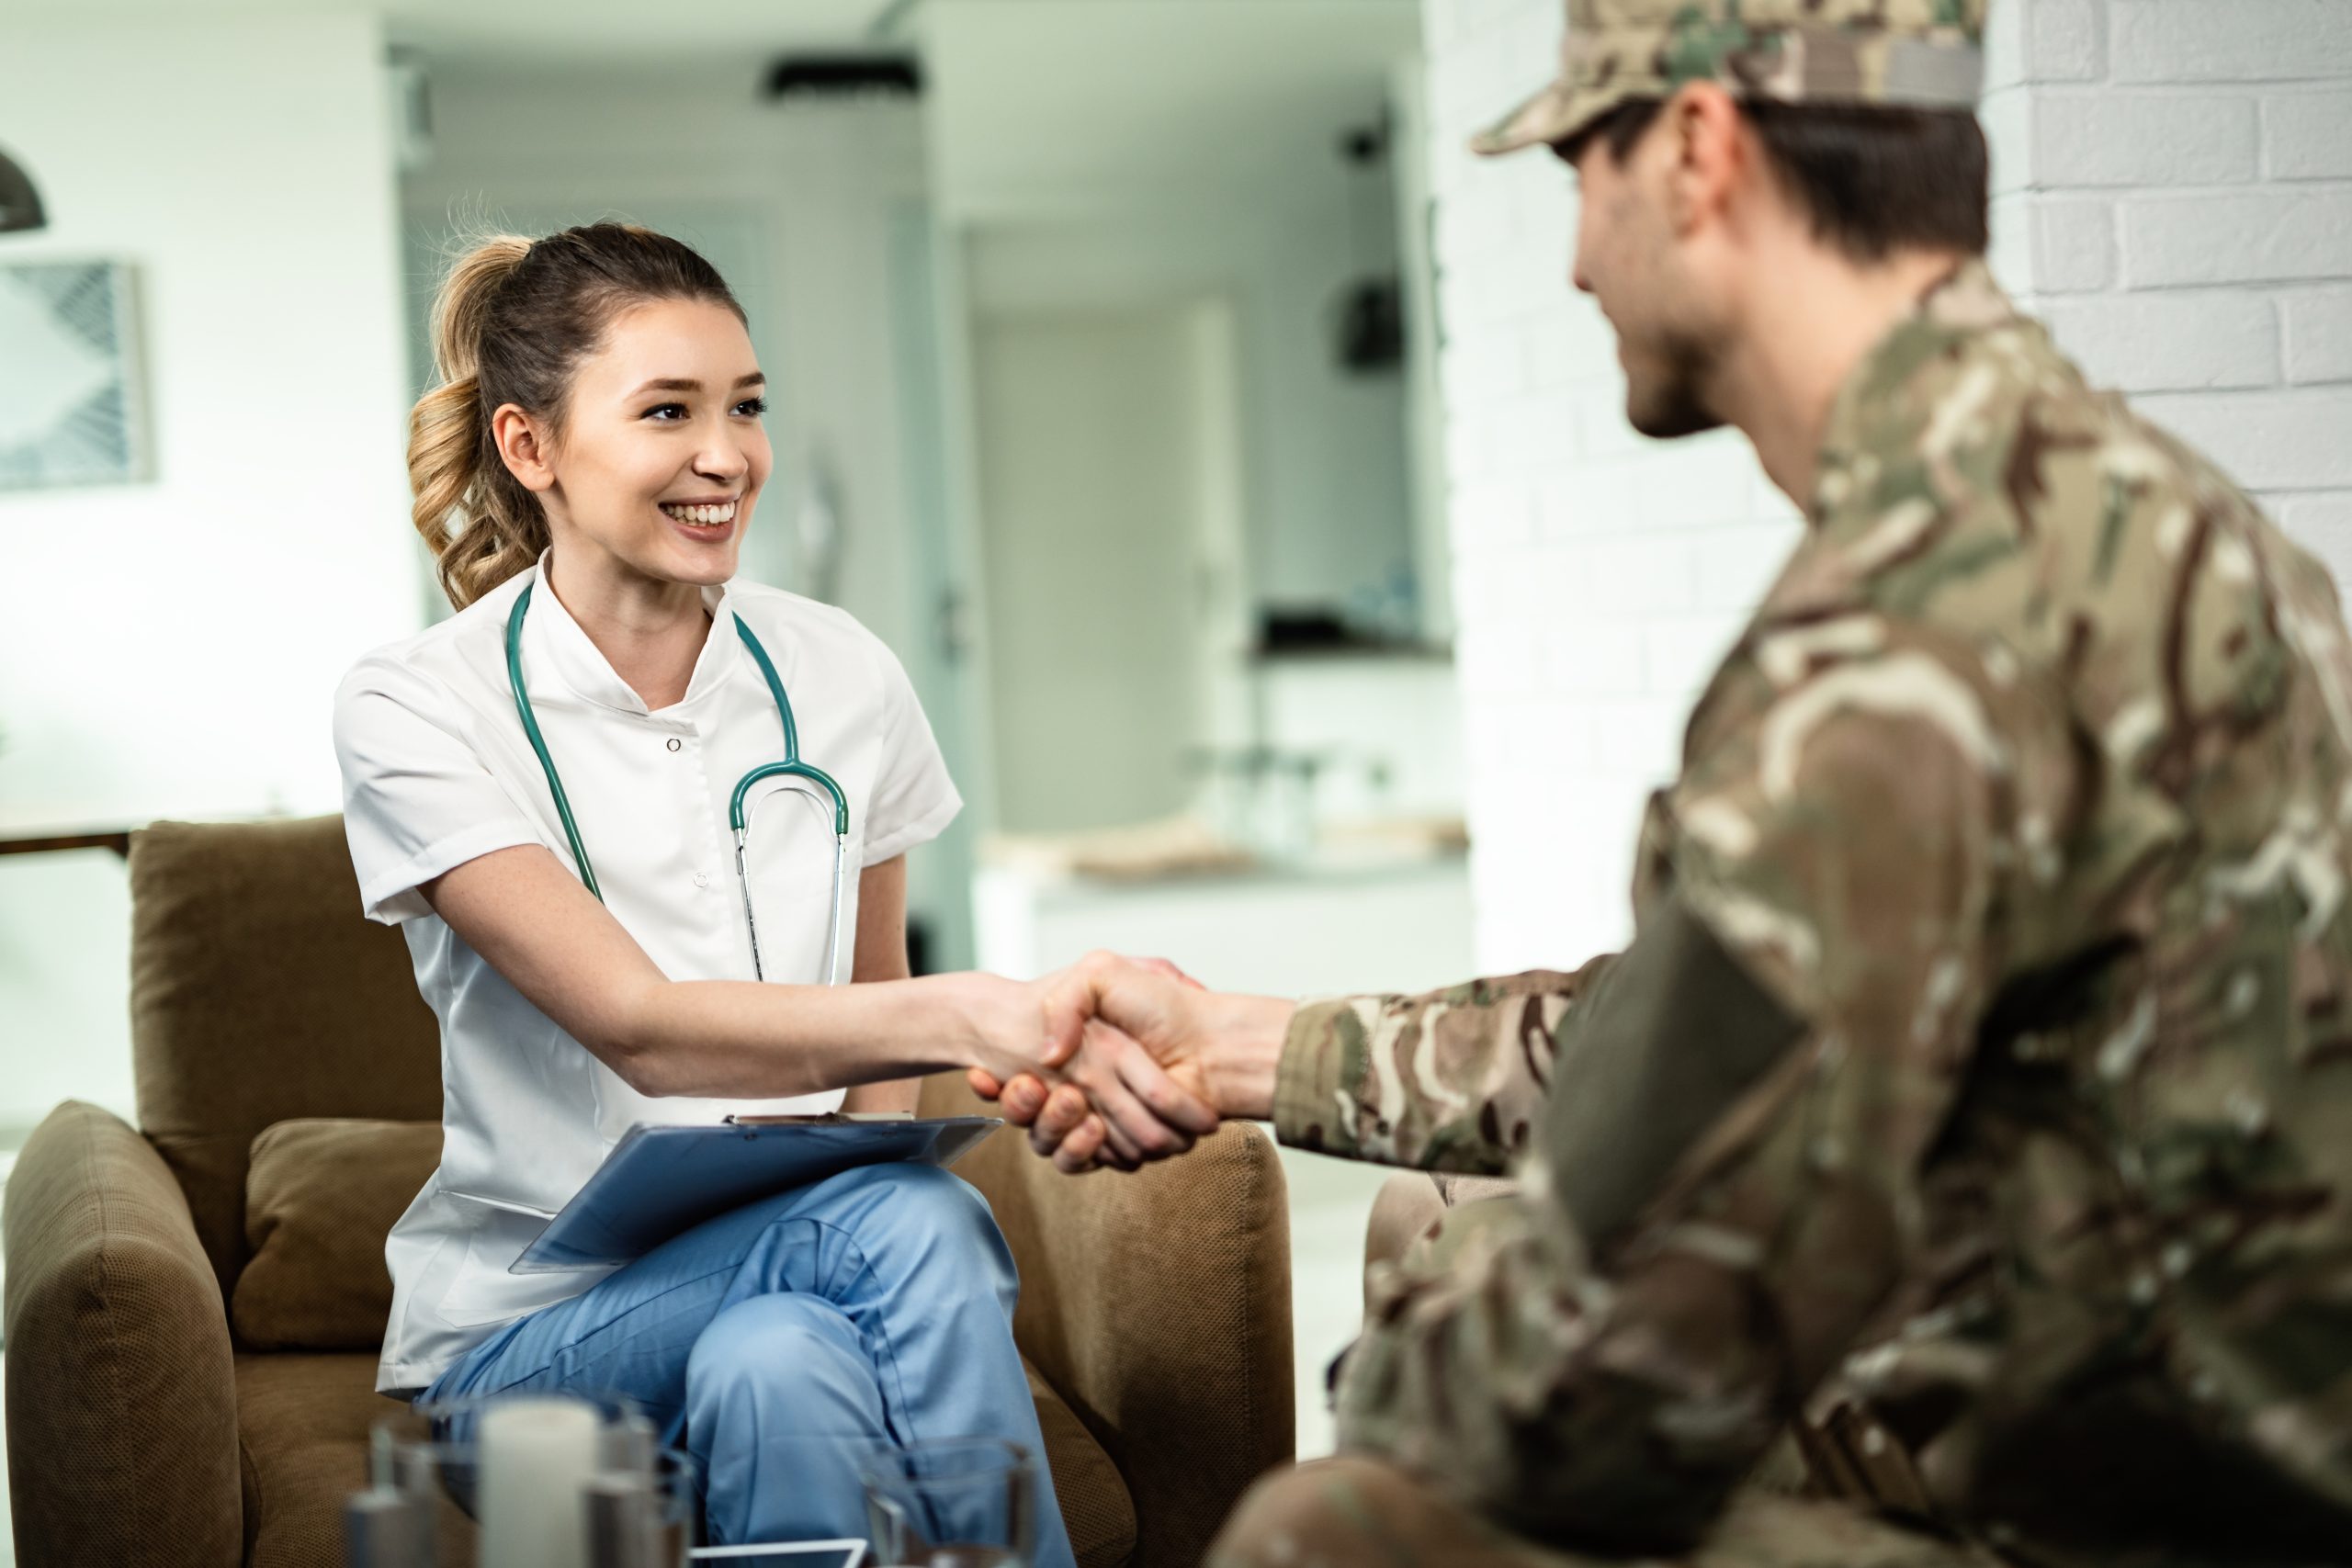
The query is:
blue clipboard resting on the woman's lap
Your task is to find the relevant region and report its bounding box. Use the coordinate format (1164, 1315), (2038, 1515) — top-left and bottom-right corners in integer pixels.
(505, 1112), (1004, 1274)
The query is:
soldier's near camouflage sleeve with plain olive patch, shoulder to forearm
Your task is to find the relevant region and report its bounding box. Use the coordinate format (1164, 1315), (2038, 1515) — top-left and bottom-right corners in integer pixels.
(1339, 627), (2067, 1551)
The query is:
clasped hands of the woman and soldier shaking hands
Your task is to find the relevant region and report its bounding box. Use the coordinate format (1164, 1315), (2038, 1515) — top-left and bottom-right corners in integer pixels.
(969, 952), (1296, 1176)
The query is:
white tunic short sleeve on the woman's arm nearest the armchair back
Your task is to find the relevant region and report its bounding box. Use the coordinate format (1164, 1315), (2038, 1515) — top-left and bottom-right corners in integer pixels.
(334, 659), (543, 926)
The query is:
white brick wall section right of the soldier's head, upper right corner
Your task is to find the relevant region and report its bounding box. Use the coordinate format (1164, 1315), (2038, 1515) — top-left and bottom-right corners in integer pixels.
(1987, 0), (2352, 581)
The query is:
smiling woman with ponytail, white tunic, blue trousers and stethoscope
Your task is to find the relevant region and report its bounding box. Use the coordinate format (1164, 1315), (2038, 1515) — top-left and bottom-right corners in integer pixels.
(334, 223), (1214, 1568)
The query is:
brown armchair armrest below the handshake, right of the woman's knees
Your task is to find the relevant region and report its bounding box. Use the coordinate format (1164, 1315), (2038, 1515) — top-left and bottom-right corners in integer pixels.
(922, 1075), (1298, 1568)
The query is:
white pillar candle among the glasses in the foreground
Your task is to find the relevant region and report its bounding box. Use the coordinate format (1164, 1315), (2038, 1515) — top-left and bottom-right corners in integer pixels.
(478, 1399), (605, 1568)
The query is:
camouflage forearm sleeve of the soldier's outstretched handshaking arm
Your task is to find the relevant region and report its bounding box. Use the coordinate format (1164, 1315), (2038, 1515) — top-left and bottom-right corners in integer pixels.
(1275, 957), (1609, 1176)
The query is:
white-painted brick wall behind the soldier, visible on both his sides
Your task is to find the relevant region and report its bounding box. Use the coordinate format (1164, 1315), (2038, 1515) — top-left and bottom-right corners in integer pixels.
(1423, 0), (2352, 968)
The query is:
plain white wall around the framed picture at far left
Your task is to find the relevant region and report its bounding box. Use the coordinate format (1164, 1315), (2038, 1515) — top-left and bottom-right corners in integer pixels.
(0, 14), (416, 1123)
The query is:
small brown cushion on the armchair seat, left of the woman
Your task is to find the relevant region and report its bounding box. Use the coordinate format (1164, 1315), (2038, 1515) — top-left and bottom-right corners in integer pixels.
(228, 1119), (442, 1352)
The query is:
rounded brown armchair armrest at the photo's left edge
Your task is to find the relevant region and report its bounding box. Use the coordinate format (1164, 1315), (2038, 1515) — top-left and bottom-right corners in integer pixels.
(0, 1100), (244, 1568)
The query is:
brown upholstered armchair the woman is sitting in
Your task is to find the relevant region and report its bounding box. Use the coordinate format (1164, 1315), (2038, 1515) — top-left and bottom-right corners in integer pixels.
(5, 818), (1294, 1568)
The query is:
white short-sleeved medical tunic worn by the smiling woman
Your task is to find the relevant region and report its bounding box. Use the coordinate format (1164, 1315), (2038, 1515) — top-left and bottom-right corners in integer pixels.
(334, 559), (962, 1392)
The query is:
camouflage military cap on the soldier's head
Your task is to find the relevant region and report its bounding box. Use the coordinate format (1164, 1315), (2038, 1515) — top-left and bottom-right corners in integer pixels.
(1470, 0), (1990, 152)
